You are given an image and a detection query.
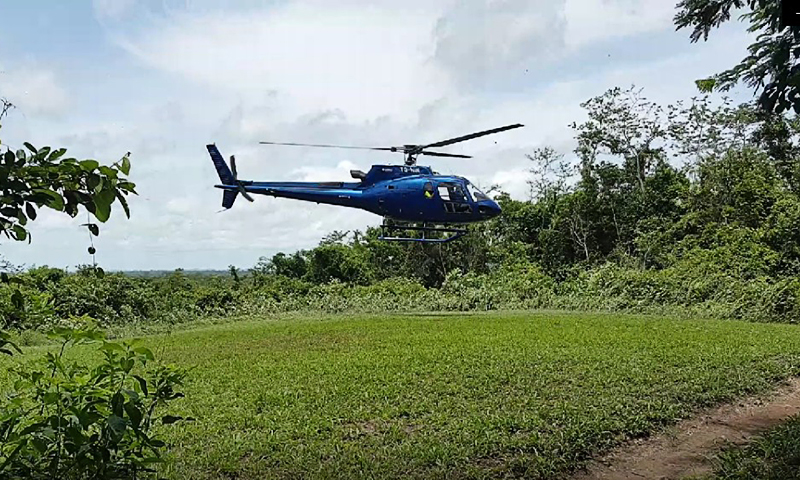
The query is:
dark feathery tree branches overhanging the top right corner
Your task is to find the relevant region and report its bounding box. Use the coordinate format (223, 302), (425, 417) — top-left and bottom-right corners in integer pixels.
(674, 0), (800, 113)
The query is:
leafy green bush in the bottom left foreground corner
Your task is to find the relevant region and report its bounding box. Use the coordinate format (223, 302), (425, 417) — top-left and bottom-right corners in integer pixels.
(0, 328), (191, 479)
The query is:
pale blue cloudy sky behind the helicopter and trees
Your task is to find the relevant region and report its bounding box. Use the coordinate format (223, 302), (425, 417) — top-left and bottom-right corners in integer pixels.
(0, 0), (752, 270)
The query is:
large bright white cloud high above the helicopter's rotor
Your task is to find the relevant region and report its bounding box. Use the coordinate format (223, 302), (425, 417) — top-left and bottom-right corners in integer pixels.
(108, 3), (450, 122)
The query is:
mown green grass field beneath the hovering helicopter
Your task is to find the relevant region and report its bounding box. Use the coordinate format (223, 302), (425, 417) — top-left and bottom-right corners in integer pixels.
(4, 313), (800, 479)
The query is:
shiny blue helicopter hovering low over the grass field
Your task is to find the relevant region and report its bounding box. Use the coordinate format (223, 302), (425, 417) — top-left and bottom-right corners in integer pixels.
(206, 124), (523, 243)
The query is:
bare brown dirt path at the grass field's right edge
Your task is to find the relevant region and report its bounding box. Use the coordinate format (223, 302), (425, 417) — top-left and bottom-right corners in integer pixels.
(573, 378), (800, 480)
